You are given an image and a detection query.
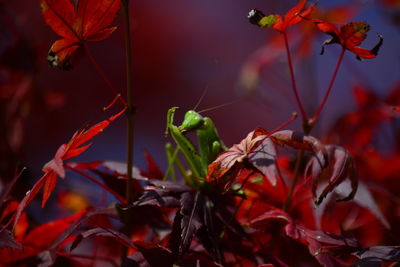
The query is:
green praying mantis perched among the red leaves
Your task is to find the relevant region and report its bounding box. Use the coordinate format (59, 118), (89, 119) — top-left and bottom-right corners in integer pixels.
(164, 107), (226, 186)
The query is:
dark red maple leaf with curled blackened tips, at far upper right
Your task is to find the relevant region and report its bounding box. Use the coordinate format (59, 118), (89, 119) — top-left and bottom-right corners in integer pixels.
(311, 20), (383, 60)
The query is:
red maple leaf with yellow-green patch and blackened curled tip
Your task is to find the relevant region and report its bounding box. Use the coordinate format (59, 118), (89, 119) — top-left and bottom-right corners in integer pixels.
(248, 0), (312, 32)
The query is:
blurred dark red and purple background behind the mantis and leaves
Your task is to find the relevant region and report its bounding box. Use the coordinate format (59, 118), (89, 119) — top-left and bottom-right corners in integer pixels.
(0, 0), (400, 218)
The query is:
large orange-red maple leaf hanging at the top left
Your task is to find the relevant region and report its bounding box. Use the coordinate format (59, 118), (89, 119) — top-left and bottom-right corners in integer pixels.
(40, 0), (121, 70)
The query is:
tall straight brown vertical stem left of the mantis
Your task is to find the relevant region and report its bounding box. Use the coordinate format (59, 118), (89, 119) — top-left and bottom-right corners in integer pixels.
(122, 0), (136, 204)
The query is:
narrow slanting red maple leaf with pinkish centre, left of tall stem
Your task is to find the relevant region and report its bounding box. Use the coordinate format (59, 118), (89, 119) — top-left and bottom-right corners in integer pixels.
(14, 109), (125, 229)
